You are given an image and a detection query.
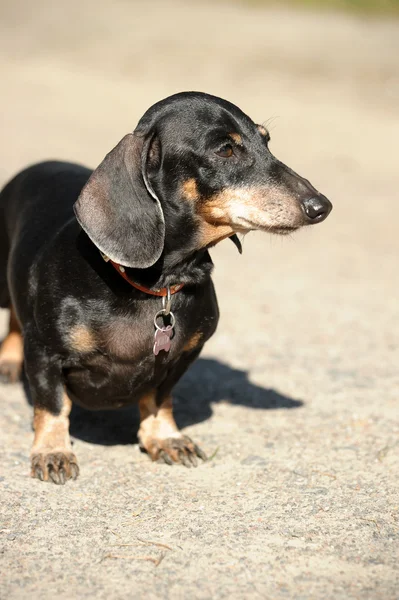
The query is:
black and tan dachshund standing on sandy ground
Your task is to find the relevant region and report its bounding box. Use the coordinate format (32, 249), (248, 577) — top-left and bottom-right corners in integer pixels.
(0, 92), (331, 483)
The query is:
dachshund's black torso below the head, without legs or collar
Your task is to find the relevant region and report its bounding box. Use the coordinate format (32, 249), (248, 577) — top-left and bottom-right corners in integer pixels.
(3, 163), (218, 412)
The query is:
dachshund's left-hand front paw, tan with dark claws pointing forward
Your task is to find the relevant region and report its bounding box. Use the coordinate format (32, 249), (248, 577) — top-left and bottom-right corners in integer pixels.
(31, 451), (79, 485)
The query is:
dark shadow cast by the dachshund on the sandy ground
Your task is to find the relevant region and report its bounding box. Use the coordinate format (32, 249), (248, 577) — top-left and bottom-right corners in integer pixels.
(65, 358), (303, 446)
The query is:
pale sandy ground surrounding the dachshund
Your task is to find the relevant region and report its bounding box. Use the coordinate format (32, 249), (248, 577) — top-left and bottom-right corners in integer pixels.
(0, 0), (399, 600)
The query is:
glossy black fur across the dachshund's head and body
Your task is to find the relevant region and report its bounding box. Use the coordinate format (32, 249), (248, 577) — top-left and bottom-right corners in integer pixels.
(0, 92), (330, 422)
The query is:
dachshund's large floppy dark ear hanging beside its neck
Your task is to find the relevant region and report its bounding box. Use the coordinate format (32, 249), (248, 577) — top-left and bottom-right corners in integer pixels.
(74, 133), (165, 269)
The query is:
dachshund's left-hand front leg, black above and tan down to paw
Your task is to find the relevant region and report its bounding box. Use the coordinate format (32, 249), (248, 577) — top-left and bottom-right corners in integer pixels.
(25, 336), (79, 484)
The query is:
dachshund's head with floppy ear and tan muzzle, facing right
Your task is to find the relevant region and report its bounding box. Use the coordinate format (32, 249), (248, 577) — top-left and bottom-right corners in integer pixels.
(75, 92), (332, 268)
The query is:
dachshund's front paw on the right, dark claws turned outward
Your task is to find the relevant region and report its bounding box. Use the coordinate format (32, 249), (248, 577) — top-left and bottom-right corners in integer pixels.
(145, 435), (207, 467)
